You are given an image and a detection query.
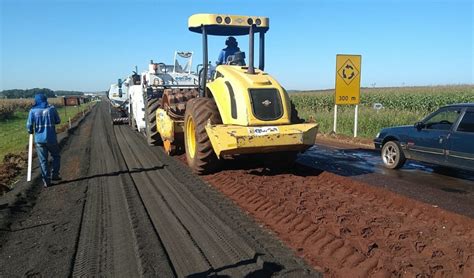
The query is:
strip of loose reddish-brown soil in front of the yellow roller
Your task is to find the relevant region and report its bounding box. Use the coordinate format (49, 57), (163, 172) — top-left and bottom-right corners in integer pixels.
(188, 157), (474, 277)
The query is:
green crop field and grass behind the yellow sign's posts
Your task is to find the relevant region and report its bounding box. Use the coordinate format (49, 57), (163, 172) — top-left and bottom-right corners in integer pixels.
(290, 85), (474, 139)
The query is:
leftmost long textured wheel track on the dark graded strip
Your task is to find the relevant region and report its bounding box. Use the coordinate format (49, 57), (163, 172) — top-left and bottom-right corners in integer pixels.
(72, 103), (140, 276)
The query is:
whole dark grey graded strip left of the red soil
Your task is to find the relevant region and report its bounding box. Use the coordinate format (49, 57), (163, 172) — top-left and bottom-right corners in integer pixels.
(0, 102), (319, 277)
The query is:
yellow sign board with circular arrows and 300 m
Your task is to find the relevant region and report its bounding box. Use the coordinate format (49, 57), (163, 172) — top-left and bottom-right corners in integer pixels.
(335, 54), (362, 105)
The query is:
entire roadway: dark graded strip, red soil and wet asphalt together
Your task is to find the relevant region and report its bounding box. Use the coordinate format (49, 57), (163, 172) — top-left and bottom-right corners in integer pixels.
(0, 100), (474, 277)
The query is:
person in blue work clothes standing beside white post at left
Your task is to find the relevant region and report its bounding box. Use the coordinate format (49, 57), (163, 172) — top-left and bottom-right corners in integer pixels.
(26, 93), (61, 187)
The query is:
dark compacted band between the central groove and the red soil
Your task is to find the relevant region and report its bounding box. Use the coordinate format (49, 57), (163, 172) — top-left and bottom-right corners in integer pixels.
(121, 127), (320, 277)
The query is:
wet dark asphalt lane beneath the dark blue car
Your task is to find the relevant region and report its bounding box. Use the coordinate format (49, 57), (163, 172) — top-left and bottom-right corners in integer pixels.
(299, 143), (474, 218)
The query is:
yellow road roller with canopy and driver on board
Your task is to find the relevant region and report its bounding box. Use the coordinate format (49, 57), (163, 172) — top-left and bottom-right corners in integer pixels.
(157, 14), (318, 174)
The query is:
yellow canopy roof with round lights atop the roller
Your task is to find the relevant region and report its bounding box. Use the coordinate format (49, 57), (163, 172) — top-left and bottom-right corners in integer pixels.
(188, 14), (270, 36)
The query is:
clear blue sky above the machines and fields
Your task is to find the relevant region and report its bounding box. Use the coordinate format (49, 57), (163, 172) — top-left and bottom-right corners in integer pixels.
(0, 0), (474, 91)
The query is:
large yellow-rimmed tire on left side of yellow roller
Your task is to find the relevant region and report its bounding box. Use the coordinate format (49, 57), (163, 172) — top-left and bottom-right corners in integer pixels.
(184, 98), (222, 175)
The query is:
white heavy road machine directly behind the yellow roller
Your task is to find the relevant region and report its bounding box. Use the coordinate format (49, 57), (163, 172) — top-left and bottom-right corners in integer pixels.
(124, 51), (199, 148)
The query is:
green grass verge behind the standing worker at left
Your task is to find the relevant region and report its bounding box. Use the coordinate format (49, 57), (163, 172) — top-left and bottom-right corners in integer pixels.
(0, 103), (93, 163)
